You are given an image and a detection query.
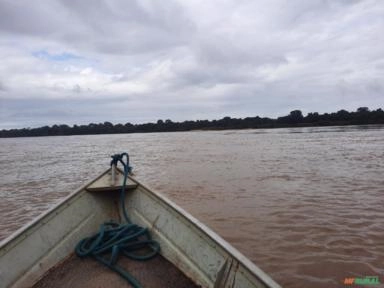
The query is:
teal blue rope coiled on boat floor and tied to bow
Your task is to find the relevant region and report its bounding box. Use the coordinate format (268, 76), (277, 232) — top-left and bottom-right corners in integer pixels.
(75, 153), (160, 288)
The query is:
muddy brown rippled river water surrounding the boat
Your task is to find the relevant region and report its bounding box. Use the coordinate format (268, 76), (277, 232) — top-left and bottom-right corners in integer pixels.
(0, 126), (384, 288)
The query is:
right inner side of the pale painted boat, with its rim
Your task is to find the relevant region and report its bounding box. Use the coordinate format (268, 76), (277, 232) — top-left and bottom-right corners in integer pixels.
(126, 177), (280, 288)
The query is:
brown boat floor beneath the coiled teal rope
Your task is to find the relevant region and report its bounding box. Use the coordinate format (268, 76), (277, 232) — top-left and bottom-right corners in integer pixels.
(32, 255), (200, 288)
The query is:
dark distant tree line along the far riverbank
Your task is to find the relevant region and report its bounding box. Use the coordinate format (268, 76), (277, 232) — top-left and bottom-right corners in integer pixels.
(0, 107), (384, 138)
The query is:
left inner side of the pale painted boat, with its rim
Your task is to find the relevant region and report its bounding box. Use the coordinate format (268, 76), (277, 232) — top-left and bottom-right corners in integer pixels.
(0, 172), (117, 288)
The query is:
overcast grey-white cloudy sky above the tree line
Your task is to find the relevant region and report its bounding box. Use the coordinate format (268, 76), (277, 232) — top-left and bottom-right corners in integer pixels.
(0, 0), (384, 129)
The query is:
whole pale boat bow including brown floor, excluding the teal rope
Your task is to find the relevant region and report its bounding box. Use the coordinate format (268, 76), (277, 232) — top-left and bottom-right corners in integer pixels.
(0, 169), (280, 288)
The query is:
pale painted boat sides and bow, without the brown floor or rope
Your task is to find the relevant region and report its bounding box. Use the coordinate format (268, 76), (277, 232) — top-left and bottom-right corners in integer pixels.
(0, 170), (280, 288)
